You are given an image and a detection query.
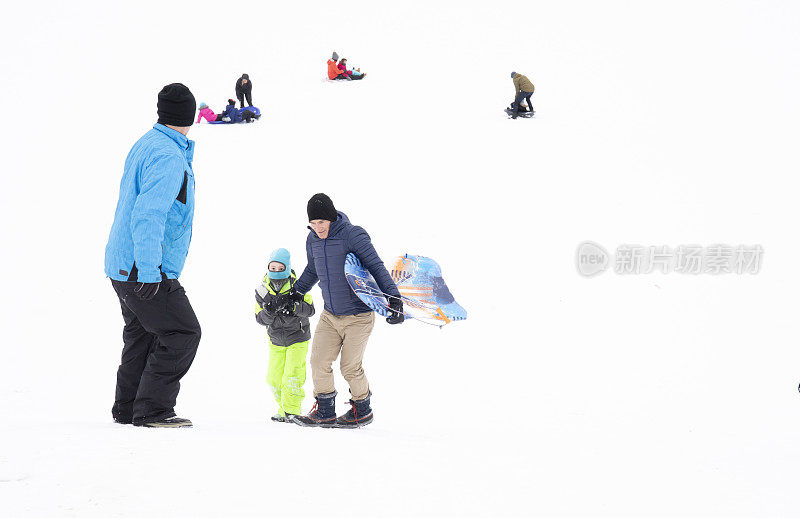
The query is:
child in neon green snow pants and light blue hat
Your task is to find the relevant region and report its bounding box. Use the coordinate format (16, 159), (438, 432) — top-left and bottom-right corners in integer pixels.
(256, 248), (314, 423)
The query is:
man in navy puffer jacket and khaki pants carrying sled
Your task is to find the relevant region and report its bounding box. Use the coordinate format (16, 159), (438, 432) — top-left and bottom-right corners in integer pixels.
(292, 193), (404, 428)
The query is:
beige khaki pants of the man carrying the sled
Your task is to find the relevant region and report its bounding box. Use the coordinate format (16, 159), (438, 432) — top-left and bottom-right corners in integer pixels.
(311, 311), (375, 401)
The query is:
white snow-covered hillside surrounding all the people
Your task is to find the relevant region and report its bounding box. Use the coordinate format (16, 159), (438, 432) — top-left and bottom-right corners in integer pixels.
(0, 0), (800, 518)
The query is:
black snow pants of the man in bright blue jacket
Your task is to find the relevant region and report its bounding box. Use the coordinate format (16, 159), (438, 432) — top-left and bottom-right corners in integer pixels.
(111, 279), (200, 425)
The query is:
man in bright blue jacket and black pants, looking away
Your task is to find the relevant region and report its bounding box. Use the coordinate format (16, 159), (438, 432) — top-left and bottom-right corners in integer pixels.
(105, 83), (200, 428)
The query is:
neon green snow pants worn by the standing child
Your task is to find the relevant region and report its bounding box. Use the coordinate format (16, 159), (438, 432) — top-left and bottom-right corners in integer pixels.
(267, 341), (308, 415)
